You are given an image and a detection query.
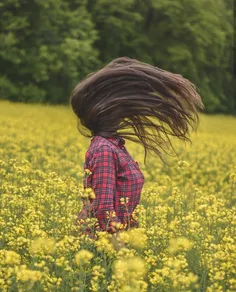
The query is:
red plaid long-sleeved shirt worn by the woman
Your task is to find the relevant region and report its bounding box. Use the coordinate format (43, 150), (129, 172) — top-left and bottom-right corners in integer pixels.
(79, 136), (144, 233)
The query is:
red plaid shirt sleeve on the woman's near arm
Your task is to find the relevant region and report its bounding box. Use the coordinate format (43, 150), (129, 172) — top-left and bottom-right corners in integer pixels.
(91, 145), (120, 233)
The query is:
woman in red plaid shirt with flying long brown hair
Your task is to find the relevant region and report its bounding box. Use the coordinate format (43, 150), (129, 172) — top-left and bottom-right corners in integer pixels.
(71, 57), (204, 237)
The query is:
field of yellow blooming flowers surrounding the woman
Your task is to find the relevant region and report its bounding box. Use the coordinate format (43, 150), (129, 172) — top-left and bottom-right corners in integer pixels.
(0, 101), (236, 292)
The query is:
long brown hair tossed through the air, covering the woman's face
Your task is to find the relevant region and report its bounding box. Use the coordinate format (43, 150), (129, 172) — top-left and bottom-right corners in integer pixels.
(70, 57), (204, 160)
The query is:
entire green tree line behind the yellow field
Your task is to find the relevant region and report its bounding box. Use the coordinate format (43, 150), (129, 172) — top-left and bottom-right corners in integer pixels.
(0, 0), (236, 114)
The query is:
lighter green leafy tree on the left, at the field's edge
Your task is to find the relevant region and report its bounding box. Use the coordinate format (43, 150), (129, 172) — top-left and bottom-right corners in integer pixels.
(0, 0), (98, 103)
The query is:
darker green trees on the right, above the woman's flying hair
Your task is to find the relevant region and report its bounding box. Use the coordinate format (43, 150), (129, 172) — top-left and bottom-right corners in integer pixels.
(88, 0), (235, 113)
